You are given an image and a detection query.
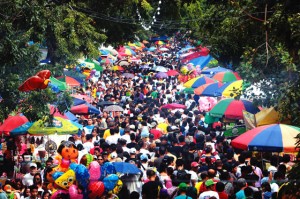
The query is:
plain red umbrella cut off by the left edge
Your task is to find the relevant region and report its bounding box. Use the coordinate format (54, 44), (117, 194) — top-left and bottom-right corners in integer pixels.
(0, 115), (28, 135)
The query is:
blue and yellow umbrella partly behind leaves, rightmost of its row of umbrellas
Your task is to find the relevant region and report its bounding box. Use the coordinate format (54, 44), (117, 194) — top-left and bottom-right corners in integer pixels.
(216, 80), (250, 97)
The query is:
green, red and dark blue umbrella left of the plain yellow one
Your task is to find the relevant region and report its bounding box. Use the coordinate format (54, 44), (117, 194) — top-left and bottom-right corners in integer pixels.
(209, 98), (259, 119)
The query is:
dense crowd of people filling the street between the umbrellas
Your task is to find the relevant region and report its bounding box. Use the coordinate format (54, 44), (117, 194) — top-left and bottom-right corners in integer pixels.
(0, 35), (293, 199)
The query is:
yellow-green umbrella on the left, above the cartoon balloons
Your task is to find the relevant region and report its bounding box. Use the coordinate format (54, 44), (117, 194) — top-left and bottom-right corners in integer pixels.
(28, 117), (79, 135)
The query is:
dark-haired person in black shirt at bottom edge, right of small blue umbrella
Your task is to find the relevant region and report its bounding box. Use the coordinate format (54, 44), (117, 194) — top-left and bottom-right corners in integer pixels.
(142, 169), (159, 199)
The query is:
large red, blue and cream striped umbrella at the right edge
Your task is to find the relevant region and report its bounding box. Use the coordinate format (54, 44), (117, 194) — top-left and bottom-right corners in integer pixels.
(231, 124), (300, 152)
